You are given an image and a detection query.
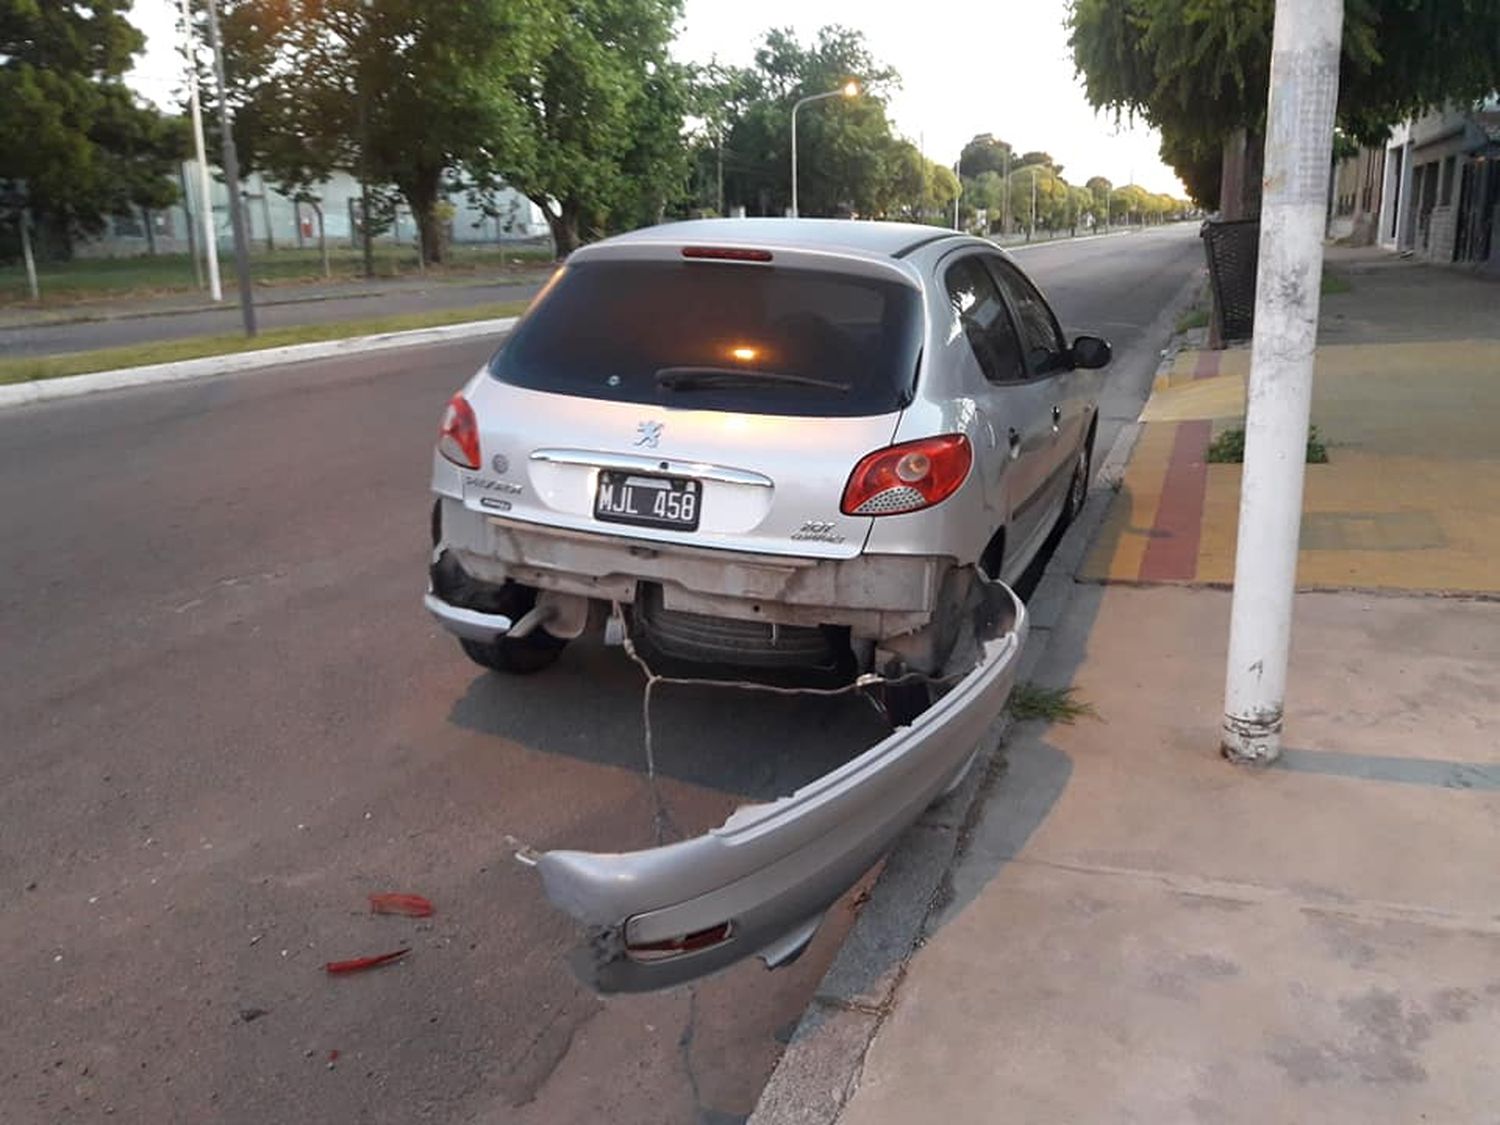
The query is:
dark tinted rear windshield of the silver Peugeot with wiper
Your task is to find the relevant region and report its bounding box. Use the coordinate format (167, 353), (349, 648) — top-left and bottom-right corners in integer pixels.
(491, 261), (923, 417)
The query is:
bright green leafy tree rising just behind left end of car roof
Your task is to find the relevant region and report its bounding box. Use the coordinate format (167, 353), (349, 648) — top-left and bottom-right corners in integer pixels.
(494, 0), (690, 257)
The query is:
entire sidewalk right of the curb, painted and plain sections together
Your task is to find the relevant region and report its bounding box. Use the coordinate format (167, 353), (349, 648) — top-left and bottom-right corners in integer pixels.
(755, 250), (1500, 1125)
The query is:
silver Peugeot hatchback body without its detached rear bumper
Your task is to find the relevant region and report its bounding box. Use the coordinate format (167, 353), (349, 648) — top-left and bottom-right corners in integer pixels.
(428, 219), (1110, 687)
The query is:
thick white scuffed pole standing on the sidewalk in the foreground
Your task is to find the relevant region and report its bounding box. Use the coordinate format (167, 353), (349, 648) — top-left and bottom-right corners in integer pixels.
(1221, 0), (1344, 765)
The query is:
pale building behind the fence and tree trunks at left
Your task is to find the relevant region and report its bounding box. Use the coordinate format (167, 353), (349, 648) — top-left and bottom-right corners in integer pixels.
(74, 161), (551, 258)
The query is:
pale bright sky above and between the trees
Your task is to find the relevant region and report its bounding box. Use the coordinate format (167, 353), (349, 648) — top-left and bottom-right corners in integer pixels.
(131, 0), (1187, 197)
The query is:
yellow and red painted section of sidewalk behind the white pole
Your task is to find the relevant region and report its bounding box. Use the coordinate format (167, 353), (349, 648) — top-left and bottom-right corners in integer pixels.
(1082, 341), (1500, 594)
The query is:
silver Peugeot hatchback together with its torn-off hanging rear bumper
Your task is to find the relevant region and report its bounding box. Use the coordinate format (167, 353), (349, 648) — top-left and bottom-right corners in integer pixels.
(426, 219), (1110, 992)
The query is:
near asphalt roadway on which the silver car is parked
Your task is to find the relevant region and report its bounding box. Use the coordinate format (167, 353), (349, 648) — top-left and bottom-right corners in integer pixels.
(0, 231), (1200, 1125)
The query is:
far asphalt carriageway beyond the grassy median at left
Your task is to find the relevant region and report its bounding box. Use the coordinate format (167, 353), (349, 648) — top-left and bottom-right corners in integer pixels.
(0, 267), (546, 357)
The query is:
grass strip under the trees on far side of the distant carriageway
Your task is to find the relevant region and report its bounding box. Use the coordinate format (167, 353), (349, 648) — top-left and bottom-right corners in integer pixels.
(0, 246), (552, 308)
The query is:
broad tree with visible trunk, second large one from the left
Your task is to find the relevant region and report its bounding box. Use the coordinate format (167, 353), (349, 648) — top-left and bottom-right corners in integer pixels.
(207, 0), (546, 263)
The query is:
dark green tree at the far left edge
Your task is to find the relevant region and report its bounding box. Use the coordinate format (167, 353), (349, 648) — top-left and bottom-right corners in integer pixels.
(0, 0), (185, 255)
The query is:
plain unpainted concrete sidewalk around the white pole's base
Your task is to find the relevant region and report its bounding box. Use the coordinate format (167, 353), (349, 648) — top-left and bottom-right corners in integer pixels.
(839, 585), (1500, 1125)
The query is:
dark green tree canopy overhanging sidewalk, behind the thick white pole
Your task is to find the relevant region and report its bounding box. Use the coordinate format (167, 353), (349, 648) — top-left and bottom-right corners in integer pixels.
(1070, 0), (1500, 207)
